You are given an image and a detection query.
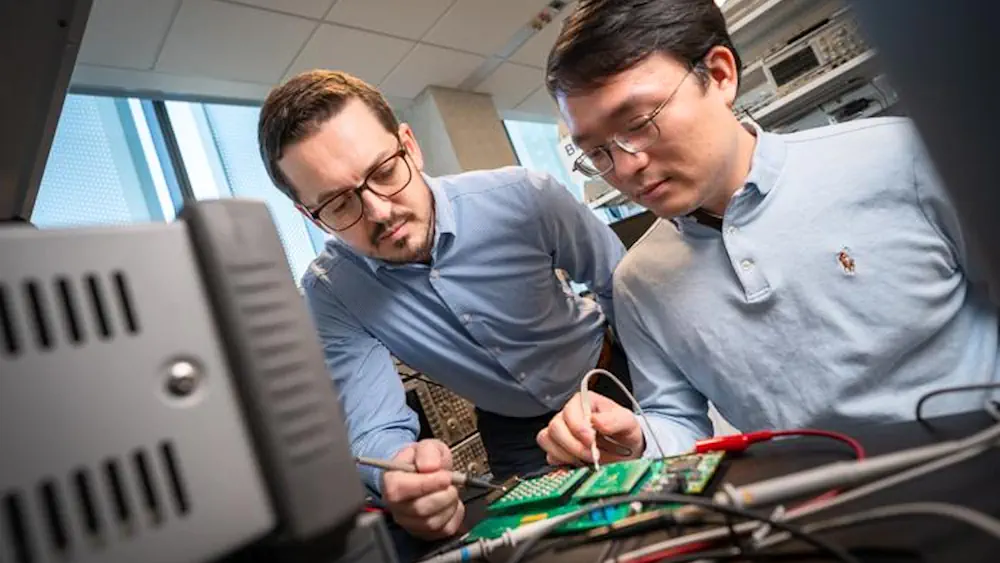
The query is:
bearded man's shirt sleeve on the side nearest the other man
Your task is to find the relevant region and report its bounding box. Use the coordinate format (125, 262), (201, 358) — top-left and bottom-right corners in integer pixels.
(528, 171), (625, 324)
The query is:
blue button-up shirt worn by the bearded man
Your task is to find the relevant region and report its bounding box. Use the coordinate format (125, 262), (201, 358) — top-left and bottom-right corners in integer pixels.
(302, 167), (625, 490)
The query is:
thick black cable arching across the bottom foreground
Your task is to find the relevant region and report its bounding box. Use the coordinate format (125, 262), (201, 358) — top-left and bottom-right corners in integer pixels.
(507, 493), (860, 563)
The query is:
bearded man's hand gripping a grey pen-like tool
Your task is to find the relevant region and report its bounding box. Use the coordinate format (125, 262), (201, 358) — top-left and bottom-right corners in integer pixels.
(382, 440), (465, 540)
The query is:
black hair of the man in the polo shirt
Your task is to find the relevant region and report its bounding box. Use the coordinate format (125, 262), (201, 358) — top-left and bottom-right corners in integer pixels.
(545, 0), (743, 96)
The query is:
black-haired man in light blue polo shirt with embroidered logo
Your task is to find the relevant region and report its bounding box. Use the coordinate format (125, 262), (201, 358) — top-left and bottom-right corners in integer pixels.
(538, 0), (1000, 463)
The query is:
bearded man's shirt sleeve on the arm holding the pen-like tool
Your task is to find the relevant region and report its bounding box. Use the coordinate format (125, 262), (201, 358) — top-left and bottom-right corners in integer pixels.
(303, 270), (419, 494)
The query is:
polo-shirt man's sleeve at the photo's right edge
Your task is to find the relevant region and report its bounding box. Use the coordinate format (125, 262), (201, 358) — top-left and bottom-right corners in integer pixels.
(911, 130), (1000, 304)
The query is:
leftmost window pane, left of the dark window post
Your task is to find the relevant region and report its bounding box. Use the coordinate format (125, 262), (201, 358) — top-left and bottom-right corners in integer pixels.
(31, 94), (174, 228)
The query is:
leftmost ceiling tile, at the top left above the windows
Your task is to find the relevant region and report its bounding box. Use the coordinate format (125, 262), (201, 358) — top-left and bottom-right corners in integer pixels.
(77, 0), (180, 70)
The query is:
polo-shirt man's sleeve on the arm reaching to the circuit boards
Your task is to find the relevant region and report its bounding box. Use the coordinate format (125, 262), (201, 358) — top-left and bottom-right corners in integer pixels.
(614, 274), (712, 457)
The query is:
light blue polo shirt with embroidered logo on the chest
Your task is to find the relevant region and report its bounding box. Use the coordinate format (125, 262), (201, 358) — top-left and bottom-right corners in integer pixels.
(614, 119), (1000, 455)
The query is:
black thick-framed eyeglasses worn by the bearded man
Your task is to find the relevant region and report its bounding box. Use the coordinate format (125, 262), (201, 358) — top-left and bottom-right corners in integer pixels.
(309, 144), (413, 236)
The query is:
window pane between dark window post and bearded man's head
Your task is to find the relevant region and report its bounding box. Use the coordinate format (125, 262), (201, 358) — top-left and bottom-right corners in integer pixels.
(166, 102), (325, 282)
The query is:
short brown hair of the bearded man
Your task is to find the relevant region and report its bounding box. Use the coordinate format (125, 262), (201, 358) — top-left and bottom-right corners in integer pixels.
(257, 70), (399, 201)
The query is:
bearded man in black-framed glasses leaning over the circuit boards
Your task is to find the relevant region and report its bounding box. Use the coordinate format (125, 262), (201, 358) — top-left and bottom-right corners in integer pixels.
(258, 71), (626, 538)
